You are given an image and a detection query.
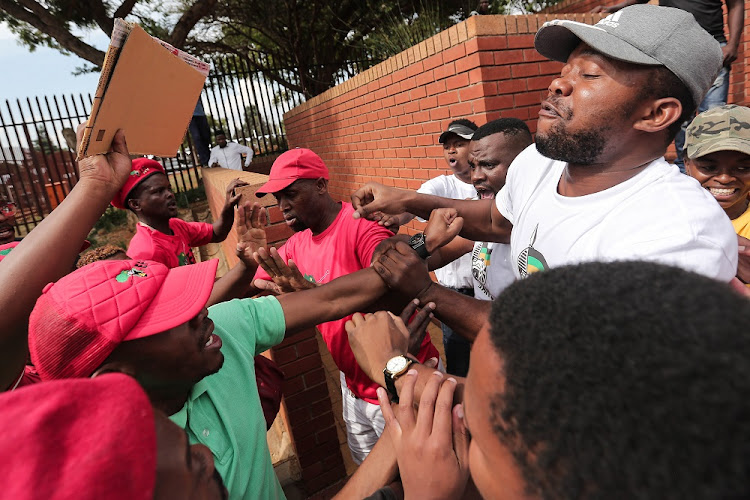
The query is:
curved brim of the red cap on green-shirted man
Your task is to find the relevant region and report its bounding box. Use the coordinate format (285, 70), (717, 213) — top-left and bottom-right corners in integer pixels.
(123, 259), (219, 341)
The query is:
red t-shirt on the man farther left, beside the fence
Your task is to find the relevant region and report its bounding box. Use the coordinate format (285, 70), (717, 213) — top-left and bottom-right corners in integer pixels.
(128, 217), (214, 268)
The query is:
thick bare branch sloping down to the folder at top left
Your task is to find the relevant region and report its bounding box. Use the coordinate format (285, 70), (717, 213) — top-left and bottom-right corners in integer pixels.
(0, 0), (104, 66)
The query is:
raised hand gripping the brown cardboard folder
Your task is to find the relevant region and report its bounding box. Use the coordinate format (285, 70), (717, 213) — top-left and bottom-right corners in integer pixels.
(76, 123), (132, 197)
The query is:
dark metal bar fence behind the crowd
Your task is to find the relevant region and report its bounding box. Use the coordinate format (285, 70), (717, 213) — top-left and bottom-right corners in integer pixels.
(0, 53), (374, 234)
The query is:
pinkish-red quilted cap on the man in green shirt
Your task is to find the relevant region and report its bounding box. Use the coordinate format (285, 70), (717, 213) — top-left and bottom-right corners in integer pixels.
(29, 259), (219, 380)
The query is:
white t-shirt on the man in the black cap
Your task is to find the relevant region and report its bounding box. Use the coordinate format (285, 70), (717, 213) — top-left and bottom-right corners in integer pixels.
(417, 174), (477, 288)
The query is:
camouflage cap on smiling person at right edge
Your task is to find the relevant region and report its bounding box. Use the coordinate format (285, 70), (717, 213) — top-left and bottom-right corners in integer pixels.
(685, 104), (750, 158)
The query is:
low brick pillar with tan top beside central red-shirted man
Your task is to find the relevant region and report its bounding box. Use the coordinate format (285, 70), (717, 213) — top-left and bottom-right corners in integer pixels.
(203, 168), (346, 494)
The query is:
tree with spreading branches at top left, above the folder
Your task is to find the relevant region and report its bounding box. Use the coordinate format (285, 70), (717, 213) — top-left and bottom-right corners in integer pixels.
(0, 0), (218, 69)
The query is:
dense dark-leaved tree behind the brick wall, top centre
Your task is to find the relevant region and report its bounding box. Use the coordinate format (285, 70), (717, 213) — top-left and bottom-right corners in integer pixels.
(187, 0), (467, 98)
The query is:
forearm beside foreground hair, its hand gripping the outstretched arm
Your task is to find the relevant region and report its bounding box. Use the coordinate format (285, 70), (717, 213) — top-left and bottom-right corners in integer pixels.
(419, 283), (492, 341)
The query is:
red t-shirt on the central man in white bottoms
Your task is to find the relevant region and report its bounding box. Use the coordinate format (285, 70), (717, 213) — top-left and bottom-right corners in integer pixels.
(255, 202), (439, 404)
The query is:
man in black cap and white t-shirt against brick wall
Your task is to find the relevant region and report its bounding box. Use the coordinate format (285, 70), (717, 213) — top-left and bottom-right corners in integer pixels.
(380, 118), (477, 377)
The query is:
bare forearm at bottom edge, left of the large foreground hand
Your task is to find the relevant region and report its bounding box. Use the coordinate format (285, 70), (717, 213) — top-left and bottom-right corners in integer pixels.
(333, 428), (398, 500)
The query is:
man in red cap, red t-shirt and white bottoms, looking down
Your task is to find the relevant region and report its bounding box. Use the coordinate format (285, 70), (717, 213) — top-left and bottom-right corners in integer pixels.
(255, 148), (439, 463)
